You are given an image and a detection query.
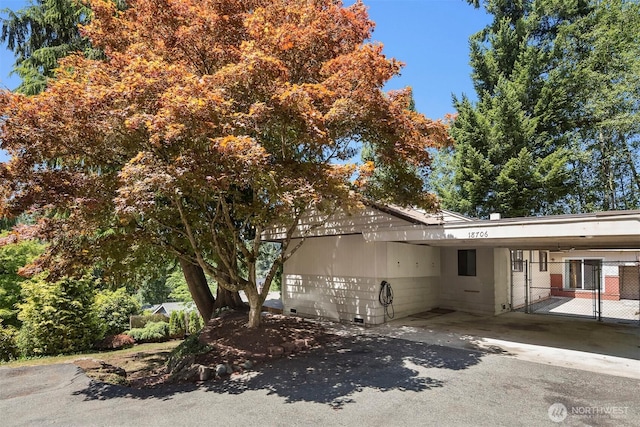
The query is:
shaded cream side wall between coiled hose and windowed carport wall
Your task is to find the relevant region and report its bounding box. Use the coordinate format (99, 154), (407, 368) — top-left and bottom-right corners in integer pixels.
(383, 243), (440, 318)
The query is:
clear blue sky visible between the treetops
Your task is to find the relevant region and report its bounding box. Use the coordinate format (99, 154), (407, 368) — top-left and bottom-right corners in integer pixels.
(0, 0), (490, 161)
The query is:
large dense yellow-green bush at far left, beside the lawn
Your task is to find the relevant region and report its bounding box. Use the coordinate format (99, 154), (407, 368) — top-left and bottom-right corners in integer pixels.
(17, 274), (102, 356)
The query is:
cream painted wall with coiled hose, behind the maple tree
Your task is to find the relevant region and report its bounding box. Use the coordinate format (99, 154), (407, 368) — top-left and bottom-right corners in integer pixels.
(282, 235), (440, 324)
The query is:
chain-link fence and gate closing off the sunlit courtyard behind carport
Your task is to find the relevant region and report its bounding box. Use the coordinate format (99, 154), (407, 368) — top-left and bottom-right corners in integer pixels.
(511, 258), (640, 326)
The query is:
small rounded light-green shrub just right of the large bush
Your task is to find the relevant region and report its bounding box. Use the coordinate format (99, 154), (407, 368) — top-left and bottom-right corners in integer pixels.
(96, 288), (140, 336)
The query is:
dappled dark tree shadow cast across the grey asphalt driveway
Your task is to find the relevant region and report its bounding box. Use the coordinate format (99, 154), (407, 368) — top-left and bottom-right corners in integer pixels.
(74, 336), (483, 408)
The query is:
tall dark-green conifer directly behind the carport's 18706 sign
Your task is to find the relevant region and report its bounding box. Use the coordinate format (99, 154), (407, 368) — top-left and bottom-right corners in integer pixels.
(433, 0), (588, 217)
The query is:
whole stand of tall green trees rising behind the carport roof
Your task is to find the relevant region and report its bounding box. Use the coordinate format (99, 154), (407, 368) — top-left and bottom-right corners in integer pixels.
(433, 0), (640, 217)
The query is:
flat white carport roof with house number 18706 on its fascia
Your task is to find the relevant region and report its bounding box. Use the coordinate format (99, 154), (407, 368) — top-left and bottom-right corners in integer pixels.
(363, 210), (640, 250)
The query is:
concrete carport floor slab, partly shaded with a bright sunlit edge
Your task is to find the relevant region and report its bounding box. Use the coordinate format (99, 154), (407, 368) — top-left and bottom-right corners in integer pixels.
(368, 312), (640, 379)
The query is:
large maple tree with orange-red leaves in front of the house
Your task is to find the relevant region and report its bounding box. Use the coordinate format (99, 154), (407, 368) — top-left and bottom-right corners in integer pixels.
(0, 0), (450, 327)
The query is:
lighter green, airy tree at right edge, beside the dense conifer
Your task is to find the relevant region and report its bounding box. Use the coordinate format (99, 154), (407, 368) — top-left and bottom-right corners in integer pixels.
(549, 0), (640, 211)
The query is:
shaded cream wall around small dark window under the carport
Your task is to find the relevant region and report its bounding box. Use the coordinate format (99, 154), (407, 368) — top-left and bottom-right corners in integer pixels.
(439, 247), (509, 314)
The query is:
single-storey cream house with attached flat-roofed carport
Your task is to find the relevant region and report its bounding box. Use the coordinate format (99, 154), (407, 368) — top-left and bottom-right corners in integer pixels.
(270, 205), (640, 324)
